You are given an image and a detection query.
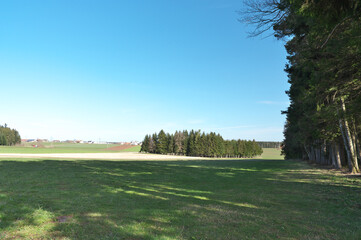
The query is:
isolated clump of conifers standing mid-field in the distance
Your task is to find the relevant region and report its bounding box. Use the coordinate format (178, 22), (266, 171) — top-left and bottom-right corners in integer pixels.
(140, 130), (263, 158)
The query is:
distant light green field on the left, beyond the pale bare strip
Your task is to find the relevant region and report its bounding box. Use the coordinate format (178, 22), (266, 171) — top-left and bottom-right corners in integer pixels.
(0, 143), (140, 153)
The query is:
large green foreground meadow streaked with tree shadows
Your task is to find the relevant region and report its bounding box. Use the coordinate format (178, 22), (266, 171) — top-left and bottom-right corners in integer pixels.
(0, 150), (361, 239)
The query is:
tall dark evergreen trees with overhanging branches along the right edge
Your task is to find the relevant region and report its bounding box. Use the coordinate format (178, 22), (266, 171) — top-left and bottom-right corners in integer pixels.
(242, 0), (361, 173)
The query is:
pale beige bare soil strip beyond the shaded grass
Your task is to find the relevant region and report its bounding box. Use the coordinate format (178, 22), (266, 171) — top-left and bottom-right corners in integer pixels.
(0, 152), (207, 161)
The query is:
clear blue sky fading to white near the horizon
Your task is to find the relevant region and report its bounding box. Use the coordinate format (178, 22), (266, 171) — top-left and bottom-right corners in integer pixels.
(0, 0), (288, 141)
